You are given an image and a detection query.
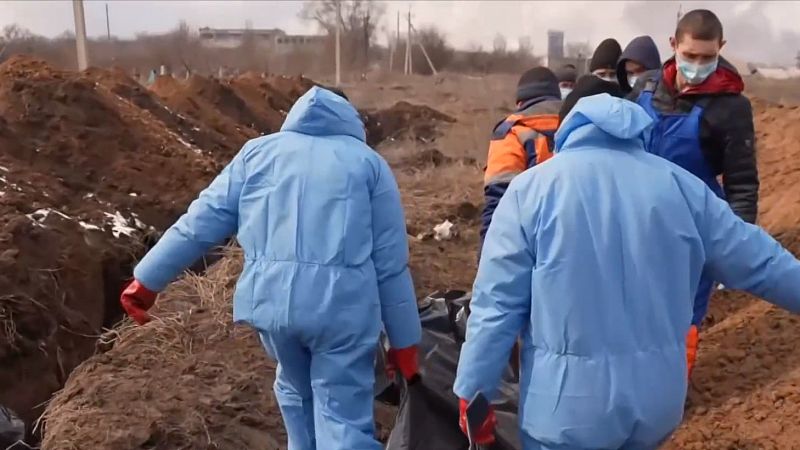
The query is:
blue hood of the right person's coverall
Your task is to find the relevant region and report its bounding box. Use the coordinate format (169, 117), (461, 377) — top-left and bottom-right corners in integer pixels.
(555, 94), (653, 152)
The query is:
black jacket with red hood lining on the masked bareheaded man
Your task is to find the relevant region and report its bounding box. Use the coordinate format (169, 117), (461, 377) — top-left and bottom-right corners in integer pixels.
(628, 58), (759, 223)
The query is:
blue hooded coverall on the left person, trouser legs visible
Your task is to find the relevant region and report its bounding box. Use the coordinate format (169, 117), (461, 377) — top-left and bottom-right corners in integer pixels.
(135, 87), (420, 450)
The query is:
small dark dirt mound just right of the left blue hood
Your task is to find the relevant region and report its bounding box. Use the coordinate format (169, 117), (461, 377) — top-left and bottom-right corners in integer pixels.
(362, 101), (456, 146)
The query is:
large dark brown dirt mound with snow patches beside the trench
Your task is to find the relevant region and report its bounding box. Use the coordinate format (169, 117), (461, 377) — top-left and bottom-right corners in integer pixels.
(0, 57), (216, 434)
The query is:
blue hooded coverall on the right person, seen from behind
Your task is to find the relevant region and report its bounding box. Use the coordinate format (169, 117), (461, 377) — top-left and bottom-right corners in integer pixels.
(454, 94), (800, 450)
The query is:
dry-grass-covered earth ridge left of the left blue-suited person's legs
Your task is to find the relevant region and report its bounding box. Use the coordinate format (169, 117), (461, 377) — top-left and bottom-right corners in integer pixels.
(42, 254), (391, 450)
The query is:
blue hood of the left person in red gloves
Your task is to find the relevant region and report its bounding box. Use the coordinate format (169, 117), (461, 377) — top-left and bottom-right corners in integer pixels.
(281, 86), (367, 142)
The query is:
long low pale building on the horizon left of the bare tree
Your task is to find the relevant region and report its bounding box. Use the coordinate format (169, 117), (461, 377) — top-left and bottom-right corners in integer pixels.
(200, 27), (326, 54)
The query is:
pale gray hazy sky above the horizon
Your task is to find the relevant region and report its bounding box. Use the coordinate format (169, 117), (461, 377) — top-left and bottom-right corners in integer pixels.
(0, 0), (800, 64)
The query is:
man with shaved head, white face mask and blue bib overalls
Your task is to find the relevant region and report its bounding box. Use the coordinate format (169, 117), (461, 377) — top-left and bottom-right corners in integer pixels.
(630, 9), (759, 374)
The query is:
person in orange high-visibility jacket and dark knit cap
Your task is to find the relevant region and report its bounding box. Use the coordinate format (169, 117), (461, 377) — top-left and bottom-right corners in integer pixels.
(480, 67), (561, 253)
